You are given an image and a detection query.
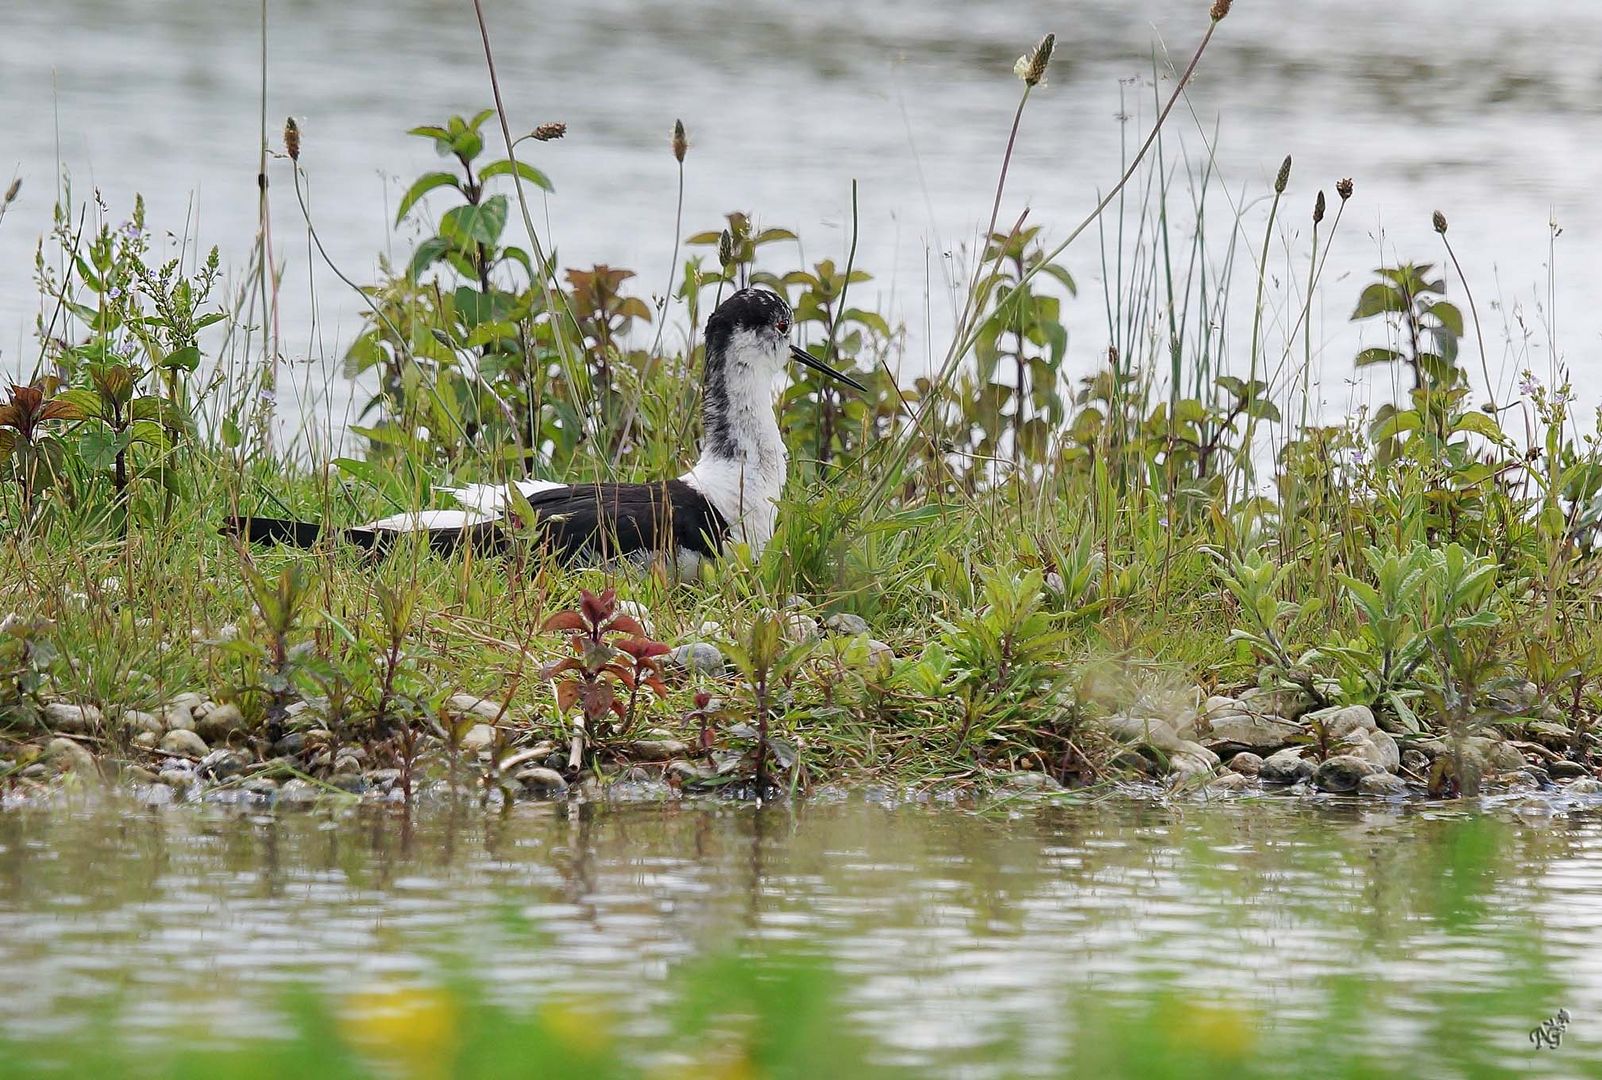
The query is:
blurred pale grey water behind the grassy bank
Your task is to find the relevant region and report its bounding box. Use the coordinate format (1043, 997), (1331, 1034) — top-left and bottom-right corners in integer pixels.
(0, 0), (1602, 435)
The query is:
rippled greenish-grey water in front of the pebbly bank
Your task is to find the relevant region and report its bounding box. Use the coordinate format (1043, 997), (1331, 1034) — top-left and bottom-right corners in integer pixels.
(0, 798), (1602, 1077)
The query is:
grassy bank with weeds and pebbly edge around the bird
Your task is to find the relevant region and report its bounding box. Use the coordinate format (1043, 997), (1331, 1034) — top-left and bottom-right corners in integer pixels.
(0, 5), (1602, 798)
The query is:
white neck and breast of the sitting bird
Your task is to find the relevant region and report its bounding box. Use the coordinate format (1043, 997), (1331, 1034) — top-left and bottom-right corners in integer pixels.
(682, 333), (788, 554)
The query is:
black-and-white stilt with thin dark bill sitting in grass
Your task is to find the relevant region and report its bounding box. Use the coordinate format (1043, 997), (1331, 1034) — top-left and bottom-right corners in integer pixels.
(235, 288), (867, 575)
